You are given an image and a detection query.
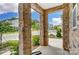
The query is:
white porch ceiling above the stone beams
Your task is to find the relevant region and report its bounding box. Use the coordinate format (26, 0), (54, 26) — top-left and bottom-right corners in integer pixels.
(38, 3), (63, 9)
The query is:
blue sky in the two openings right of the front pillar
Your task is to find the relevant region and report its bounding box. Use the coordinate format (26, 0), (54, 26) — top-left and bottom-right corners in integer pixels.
(31, 9), (63, 25)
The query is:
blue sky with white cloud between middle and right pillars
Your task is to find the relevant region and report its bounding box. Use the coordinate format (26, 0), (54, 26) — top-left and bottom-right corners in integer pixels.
(48, 10), (63, 25)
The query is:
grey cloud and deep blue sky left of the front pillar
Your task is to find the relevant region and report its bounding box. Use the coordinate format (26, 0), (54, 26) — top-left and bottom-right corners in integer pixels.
(0, 3), (18, 21)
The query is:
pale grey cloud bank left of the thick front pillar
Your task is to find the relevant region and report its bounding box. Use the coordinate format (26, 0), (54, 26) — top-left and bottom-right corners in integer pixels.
(0, 3), (18, 14)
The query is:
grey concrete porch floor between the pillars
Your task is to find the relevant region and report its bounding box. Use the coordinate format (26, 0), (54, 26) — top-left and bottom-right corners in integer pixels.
(32, 46), (69, 55)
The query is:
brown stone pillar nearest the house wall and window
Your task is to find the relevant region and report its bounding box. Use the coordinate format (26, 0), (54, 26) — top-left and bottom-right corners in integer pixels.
(63, 4), (70, 51)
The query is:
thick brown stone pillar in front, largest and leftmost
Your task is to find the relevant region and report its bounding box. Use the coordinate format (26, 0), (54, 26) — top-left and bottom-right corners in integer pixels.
(19, 3), (31, 55)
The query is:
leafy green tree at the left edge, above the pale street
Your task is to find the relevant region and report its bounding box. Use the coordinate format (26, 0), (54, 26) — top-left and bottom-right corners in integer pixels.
(0, 22), (17, 43)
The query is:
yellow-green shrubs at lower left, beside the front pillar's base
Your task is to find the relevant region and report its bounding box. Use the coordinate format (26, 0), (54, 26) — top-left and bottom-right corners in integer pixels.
(0, 40), (19, 55)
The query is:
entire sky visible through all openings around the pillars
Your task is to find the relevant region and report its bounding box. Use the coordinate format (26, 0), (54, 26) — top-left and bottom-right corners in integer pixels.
(0, 3), (63, 25)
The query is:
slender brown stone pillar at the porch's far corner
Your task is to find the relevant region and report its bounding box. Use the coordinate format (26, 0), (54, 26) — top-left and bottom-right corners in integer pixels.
(40, 11), (48, 46)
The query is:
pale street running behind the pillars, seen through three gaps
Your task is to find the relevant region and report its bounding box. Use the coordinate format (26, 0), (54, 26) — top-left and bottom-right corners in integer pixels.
(2, 30), (55, 42)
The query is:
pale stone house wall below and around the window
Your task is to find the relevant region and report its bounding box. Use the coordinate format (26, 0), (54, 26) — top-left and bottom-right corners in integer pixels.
(69, 3), (79, 55)
